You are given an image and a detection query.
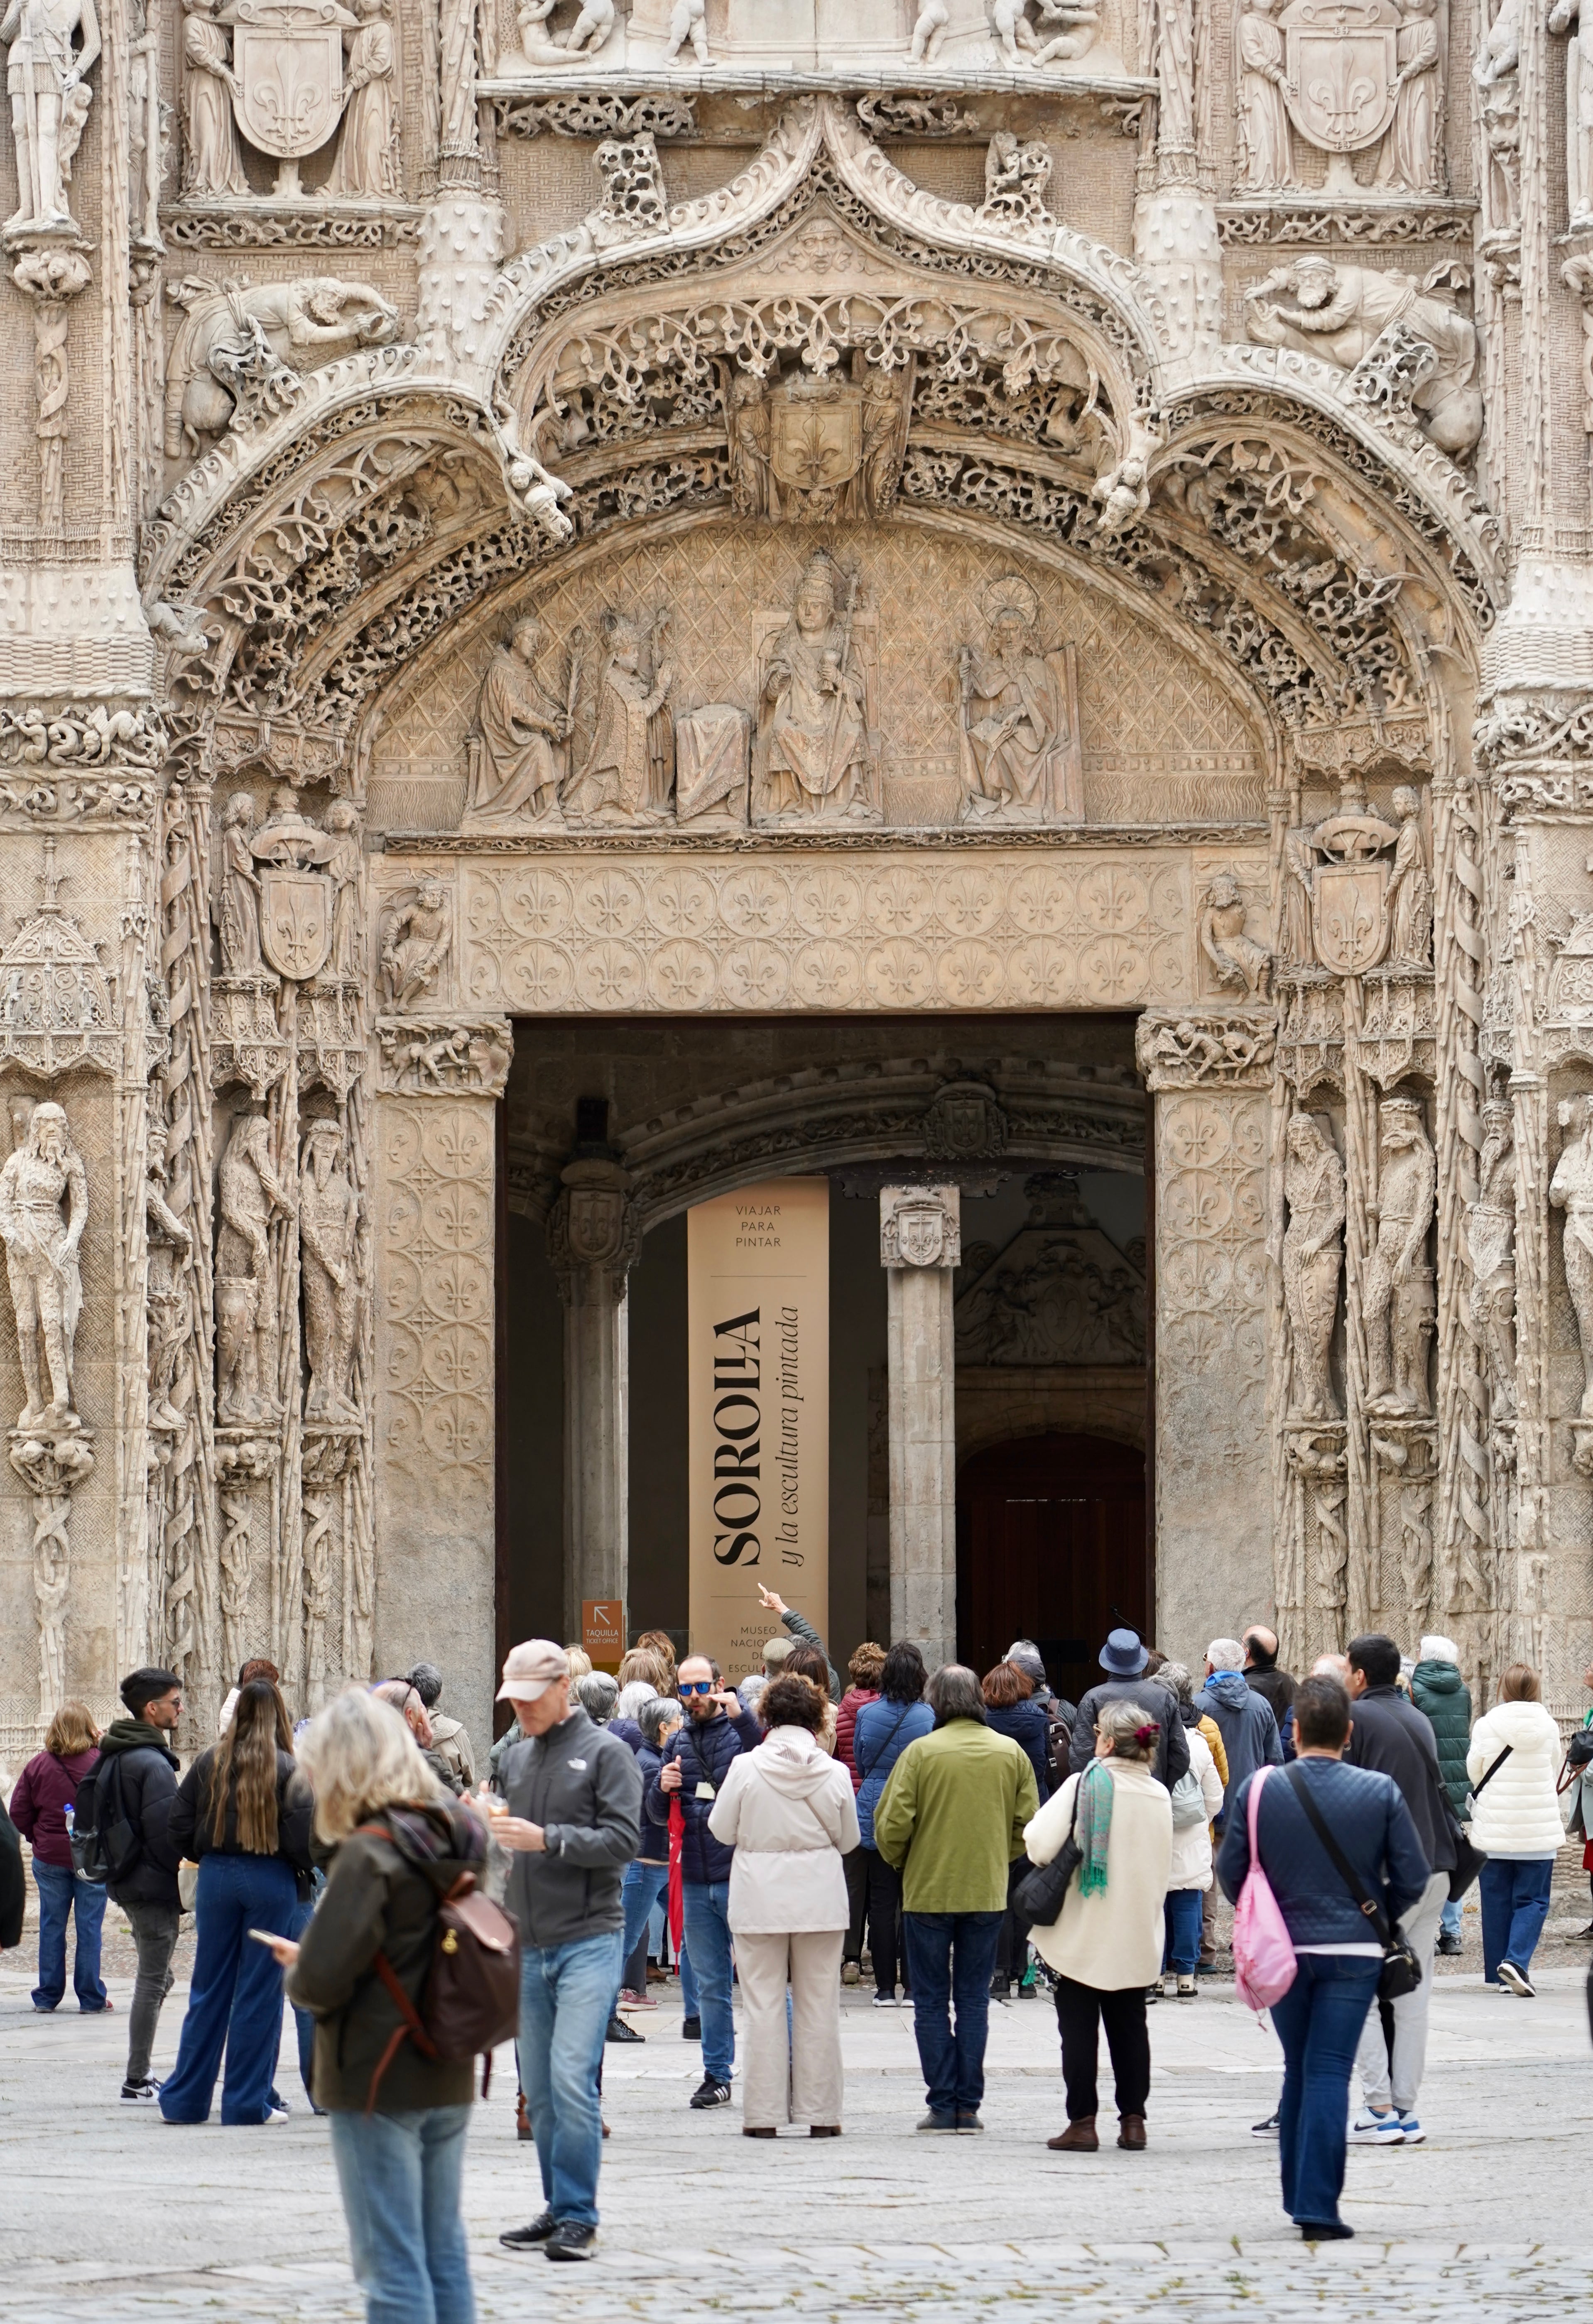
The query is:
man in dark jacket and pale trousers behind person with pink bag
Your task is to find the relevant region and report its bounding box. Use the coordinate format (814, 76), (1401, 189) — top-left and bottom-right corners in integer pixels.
(1344, 1634), (1456, 2148)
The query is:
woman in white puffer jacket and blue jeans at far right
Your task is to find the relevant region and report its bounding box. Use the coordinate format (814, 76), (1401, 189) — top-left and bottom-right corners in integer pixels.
(1465, 1662), (1565, 2001)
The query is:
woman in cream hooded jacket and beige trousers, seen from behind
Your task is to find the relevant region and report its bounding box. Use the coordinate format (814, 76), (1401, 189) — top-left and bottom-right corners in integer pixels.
(707, 1673), (860, 2138)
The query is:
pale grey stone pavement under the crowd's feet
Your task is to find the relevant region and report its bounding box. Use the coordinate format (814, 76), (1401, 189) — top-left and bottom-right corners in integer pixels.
(0, 1922), (1593, 2324)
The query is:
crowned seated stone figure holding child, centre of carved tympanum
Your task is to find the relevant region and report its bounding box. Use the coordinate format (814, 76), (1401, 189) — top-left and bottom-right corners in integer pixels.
(756, 551), (875, 818)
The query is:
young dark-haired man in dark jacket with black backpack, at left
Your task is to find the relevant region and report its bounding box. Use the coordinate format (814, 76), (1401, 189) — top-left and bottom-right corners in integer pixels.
(74, 1669), (181, 2106)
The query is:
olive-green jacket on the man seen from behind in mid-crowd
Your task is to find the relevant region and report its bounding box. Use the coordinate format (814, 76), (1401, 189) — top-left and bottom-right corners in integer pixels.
(875, 1720), (1039, 1913)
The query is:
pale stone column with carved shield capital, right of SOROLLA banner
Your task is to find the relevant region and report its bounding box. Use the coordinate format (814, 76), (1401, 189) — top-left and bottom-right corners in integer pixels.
(879, 1185), (963, 1671)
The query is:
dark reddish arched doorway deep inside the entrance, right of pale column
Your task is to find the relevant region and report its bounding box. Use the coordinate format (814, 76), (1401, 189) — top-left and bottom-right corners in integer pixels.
(956, 1432), (1149, 1701)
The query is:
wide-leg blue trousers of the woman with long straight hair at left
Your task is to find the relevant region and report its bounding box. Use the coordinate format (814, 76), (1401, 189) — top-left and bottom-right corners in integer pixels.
(160, 1850), (298, 2124)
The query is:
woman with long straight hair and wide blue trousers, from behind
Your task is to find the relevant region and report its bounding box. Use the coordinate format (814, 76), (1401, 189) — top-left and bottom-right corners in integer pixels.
(160, 1678), (309, 2124)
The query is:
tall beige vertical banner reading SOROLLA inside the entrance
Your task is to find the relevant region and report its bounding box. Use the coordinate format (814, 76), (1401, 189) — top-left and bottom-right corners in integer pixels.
(686, 1178), (830, 1682)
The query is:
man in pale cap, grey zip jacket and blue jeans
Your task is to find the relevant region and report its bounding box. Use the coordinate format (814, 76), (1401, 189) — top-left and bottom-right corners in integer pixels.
(493, 1638), (642, 2259)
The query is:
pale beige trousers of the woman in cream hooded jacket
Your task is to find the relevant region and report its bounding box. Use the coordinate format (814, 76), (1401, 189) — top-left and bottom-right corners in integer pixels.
(735, 1929), (846, 2131)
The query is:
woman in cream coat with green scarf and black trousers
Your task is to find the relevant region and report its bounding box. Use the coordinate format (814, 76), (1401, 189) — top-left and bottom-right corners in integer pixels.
(1023, 1699), (1172, 2154)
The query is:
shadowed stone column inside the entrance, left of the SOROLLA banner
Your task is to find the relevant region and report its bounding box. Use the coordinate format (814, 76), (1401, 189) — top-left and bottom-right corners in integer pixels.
(547, 1157), (642, 1638)
